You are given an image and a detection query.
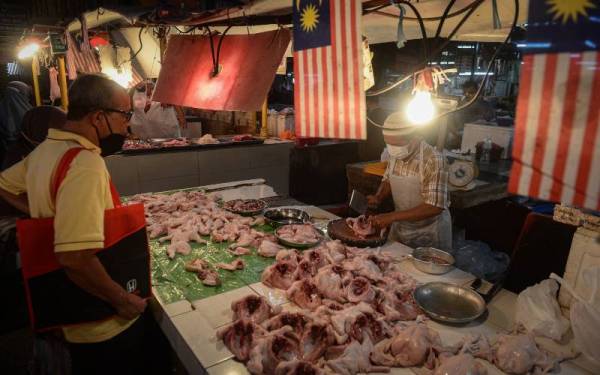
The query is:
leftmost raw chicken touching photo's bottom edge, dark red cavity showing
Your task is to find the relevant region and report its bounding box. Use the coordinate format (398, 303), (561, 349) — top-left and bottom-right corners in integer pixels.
(246, 326), (300, 374)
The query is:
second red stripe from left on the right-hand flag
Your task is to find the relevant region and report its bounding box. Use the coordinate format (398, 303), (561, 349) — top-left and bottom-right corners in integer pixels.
(529, 53), (557, 197)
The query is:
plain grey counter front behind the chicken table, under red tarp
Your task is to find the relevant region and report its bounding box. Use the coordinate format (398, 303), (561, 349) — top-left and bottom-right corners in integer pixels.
(106, 141), (293, 196)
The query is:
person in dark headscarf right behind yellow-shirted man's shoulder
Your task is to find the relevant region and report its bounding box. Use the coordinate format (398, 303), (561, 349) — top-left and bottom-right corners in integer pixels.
(2, 105), (67, 170)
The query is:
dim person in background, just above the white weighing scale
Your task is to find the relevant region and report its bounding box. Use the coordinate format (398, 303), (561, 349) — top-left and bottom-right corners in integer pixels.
(446, 81), (495, 150)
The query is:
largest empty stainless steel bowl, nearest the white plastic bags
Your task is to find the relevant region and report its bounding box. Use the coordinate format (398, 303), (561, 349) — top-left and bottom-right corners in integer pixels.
(414, 282), (485, 324)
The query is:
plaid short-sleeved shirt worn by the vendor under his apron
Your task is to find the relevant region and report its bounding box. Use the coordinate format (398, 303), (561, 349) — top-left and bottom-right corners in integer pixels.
(383, 141), (450, 212)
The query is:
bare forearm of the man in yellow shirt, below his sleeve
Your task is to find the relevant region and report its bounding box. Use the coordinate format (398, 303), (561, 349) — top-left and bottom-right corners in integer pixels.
(56, 250), (146, 319)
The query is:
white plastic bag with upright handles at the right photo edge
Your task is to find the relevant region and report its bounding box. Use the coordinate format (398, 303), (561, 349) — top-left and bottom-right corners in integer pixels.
(550, 267), (600, 371)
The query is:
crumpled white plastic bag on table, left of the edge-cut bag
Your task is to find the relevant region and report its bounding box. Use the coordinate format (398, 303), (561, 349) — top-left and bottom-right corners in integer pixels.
(516, 280), (569, 341)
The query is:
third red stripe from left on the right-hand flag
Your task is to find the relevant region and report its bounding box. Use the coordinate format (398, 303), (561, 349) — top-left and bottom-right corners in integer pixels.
(550, 54), (581, 202)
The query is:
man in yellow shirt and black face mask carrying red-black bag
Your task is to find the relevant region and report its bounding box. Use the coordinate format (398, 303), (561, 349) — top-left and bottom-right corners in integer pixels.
(0, 75), (146, 374)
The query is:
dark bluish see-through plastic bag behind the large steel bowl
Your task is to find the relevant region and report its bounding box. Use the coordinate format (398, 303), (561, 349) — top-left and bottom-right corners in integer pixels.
(451, 240), (510, 282)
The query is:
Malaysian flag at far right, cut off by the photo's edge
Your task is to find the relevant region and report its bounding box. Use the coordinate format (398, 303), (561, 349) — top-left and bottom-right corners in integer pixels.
(509, 0), (600, 210)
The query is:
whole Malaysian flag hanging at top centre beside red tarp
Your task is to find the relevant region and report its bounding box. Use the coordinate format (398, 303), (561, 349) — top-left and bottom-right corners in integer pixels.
(293, 0), (367, 139)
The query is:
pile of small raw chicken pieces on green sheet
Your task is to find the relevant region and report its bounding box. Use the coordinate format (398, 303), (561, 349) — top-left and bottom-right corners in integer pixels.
(128, 191), (283, 286)
